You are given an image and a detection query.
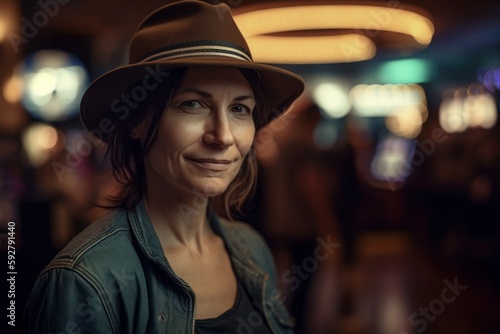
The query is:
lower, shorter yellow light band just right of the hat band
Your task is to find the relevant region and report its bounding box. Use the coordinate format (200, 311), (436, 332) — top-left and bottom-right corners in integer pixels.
(247, 34), (375, 64)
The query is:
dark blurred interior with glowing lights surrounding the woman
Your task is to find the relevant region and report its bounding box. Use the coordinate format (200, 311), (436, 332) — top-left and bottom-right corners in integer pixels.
(0, 0), (500, 334)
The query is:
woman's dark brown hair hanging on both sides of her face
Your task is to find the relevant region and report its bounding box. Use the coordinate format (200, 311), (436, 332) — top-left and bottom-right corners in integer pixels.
(98, 68), (269, 218)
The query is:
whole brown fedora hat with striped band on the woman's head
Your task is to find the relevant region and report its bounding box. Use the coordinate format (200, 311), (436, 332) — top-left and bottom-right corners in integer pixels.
(80, 0), (304, 140)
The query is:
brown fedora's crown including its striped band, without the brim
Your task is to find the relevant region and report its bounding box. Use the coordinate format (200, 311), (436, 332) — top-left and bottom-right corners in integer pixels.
(129, 0), (252, 64)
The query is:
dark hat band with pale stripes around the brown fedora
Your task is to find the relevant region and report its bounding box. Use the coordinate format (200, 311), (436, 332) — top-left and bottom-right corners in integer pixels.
(139, 45), (252, 63)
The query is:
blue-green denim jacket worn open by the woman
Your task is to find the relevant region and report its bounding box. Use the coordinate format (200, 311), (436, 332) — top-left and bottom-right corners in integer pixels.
(25, 202), (293, 334)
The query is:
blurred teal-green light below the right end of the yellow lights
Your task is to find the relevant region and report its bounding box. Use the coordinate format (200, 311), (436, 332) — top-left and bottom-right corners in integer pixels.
(377, 59), (433, 84)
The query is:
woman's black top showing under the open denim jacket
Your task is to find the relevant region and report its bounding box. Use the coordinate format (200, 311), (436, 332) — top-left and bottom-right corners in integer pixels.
(195, 280), (271, 334)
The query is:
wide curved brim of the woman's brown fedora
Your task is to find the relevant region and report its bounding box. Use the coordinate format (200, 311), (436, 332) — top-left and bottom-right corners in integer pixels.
(80, 57), (304, 140)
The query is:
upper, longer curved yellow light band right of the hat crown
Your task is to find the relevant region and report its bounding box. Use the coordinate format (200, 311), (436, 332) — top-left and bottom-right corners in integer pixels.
(235, 5), (434, 45)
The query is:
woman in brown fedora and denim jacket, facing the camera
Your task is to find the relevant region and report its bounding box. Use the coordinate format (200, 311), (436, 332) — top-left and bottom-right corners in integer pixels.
(25, 1), (303, 333)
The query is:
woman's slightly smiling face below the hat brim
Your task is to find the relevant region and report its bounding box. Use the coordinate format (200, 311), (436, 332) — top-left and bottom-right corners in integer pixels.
(145, 66), (255, 197)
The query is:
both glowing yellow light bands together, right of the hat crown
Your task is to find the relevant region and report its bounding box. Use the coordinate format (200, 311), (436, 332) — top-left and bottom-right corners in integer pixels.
(234, 5), (434, 64)
